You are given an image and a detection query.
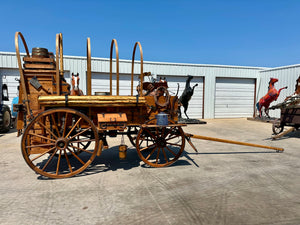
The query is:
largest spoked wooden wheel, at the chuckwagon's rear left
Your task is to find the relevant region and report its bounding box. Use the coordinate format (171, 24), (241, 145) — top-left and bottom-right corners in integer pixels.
(21, 108), (99, 178)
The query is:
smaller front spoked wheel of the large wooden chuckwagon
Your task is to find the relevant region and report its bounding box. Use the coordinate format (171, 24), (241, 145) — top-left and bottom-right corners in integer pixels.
(136, 119), (185, 167)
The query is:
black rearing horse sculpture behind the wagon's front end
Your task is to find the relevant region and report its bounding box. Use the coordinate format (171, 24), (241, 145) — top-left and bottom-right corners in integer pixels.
(178, 75), (198, 119)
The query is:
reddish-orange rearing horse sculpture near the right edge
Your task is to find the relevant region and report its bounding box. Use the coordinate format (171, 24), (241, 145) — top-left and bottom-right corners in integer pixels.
(256, 78), (287, 118)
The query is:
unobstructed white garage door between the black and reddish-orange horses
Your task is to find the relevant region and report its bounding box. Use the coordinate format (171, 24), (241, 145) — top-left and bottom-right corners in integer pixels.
(215, 78), (255, 118)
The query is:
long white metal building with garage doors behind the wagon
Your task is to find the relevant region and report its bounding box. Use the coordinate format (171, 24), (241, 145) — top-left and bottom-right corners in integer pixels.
(0, 52), (300, 119)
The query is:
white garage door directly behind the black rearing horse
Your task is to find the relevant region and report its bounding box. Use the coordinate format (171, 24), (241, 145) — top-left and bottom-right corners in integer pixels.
(164, 76), (203, 119)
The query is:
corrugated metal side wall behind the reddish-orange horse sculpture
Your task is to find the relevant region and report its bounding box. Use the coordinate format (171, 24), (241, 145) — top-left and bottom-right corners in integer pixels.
(257, 65), (300, 118)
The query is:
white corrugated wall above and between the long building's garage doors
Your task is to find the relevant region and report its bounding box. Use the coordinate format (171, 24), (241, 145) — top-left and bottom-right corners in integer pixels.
(0, 52), (265, 118)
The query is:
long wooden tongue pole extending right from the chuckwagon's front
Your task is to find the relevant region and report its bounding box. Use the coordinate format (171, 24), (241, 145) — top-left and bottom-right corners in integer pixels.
(184, 133), (284, 152)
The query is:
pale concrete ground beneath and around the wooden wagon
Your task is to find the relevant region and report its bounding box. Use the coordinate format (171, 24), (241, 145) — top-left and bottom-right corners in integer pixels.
(0, 118), (300, 225)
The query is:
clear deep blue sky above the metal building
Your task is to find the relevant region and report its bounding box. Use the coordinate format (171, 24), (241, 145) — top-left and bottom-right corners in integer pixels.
(0, 0), (300, 67)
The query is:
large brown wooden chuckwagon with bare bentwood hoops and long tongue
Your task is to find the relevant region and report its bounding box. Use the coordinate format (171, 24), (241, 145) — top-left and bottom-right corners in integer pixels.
(14, 32), (283, 178)
